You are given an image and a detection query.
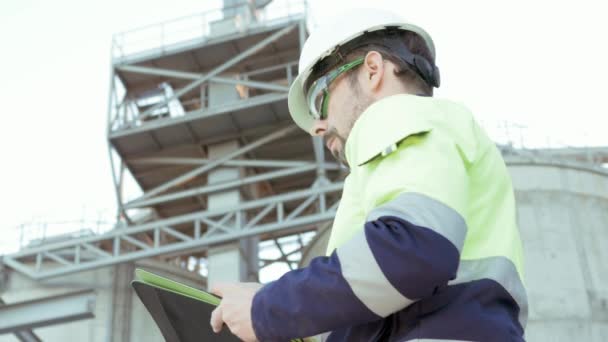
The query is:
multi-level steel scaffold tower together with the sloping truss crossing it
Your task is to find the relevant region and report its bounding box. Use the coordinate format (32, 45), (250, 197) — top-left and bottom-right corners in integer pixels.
(3, 1), (344, 280)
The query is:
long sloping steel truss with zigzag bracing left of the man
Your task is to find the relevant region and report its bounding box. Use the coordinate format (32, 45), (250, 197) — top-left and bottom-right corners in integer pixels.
(3, 183), (343, 279)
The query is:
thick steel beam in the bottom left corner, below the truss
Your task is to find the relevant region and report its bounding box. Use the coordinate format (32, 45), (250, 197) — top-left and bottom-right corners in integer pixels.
(0, 290), (95, 334)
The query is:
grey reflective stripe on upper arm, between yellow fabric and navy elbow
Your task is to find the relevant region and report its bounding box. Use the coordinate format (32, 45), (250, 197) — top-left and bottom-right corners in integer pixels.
(367, 192), (467, 252)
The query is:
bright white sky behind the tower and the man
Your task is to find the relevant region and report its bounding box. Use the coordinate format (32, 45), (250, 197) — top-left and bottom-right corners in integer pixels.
(0, 0), (608, 253)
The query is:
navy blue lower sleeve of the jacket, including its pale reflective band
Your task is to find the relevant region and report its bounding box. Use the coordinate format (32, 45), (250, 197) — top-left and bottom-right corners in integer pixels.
(252, 216), (459, 341)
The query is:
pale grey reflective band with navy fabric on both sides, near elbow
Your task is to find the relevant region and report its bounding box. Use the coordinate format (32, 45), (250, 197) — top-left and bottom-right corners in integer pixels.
(336, 231), (413, 317)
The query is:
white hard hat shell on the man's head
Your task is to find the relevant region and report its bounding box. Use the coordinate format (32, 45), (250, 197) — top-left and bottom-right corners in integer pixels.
(288, 8), (435, 132)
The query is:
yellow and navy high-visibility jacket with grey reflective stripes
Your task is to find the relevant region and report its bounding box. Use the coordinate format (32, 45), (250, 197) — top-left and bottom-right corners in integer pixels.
(252, 94), (528, 341)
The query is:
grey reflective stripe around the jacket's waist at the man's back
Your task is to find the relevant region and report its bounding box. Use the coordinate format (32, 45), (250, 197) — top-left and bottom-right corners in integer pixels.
(448, 256), (528, 328)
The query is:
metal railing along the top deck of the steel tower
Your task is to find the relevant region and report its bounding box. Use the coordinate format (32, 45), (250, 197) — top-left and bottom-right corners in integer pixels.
(112, 0), (308, 61)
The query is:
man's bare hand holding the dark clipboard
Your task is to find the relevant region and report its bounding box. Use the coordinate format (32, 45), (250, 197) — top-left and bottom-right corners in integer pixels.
(211, 283), (262, 342)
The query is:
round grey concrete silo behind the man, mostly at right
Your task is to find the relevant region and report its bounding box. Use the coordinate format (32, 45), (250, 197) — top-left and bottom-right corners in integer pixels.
(303, 157), (608, 342)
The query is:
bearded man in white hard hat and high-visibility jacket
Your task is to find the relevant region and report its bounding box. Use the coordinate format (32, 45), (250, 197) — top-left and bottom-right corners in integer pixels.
(211, 10), (527, 341)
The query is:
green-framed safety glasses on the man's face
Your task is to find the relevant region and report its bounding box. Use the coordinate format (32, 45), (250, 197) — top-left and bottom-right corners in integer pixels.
(306, 57), (365, 120)
